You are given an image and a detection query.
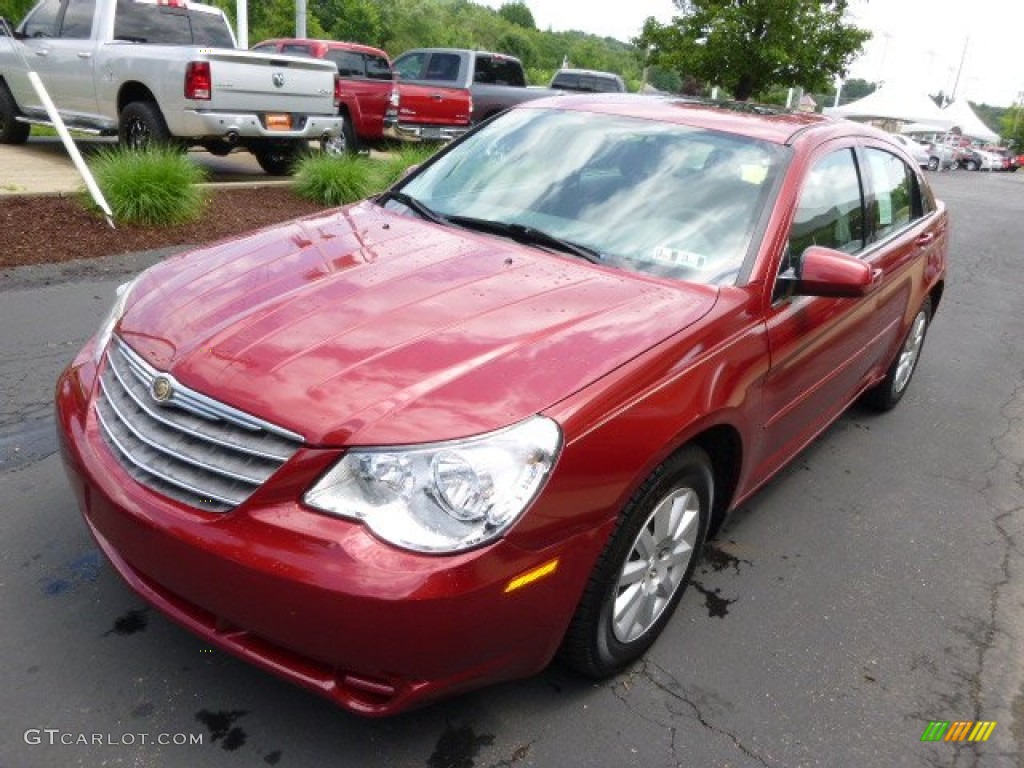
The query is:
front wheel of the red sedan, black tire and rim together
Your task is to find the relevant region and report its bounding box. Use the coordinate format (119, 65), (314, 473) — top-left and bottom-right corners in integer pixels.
(559, 445), (714, 678)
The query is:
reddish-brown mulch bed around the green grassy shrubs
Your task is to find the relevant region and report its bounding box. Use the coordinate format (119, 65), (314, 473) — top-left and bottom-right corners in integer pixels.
(0, 185), (324, 268)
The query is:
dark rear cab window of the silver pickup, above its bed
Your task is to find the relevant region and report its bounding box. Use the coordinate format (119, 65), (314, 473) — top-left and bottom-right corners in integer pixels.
(114, 0), (234, 48)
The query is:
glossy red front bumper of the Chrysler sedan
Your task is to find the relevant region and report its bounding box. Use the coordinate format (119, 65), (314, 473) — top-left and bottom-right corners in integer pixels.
(56, 347), (607, 715)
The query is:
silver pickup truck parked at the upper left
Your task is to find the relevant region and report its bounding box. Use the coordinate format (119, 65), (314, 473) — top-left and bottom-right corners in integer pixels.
(0, 0), (341, 174)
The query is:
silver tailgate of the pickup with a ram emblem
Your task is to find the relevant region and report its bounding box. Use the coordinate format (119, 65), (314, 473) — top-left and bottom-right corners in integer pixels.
(203, 48), (337, 115)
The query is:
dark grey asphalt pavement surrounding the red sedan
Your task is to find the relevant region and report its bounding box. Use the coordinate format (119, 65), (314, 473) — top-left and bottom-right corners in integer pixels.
(0, 172), (1024, 768)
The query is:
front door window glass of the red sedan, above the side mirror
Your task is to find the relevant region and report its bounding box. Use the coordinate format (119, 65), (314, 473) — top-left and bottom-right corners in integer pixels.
(782, 150), (864, 260)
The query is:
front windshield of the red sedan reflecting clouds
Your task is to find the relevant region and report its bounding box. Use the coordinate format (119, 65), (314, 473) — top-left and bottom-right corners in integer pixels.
(401, 109), (786, 284)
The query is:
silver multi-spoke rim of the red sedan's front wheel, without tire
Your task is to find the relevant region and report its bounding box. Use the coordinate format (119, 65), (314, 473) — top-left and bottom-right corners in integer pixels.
(611, 487), (700, 643)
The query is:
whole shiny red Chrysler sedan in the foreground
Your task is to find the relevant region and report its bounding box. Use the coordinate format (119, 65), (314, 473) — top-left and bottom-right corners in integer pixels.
(57, 96), (948, 715)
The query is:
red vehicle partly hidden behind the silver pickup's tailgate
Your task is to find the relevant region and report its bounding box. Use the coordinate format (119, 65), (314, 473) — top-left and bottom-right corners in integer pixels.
(252, 38), (397, 154)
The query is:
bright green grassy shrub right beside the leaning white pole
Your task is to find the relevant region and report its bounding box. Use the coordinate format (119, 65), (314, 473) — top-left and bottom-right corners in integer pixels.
(86, 147), (206, 226)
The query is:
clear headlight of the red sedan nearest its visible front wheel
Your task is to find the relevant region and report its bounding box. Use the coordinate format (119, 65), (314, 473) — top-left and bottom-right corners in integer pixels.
(304, 416), (561, 553)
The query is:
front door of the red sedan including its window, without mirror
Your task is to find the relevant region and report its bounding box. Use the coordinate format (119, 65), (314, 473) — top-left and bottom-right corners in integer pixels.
(759, 139), (879, 474)
